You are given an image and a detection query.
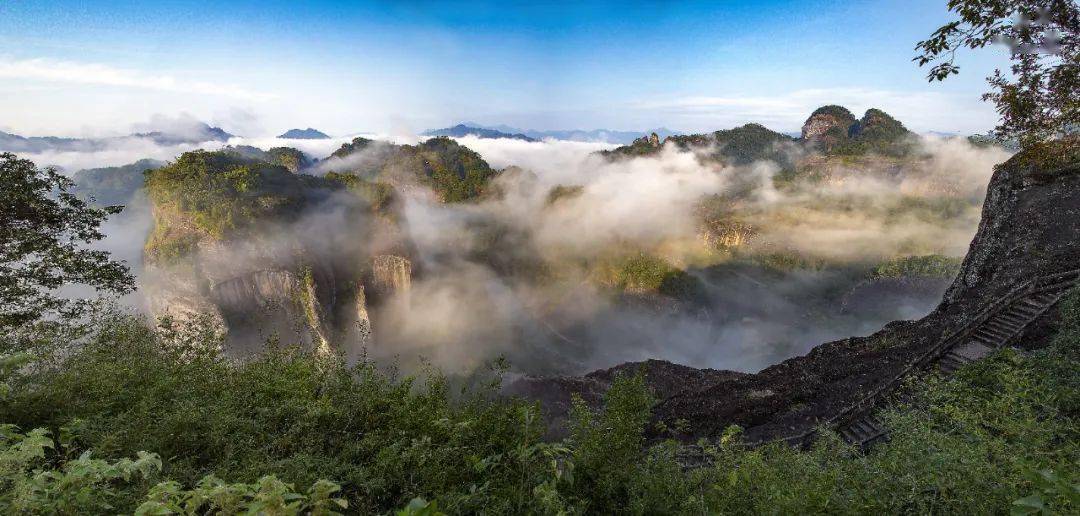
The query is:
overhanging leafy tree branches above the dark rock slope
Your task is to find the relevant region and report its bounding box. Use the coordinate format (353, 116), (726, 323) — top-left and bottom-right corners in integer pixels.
(913, 0), (1080, 146)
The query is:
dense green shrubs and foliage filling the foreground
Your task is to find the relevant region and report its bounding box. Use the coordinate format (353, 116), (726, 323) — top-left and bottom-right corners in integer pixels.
(0, 293), (1080, 514)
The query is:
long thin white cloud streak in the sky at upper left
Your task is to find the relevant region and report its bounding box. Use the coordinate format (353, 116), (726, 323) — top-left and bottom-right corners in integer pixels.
(0, 58), (278, 101)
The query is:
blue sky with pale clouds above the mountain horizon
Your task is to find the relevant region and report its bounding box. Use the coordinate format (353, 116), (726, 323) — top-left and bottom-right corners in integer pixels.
(0, 0), (1005, 135)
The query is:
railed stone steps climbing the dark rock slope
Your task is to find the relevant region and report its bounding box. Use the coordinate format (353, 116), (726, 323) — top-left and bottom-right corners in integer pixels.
(838, 271), (1080, 449)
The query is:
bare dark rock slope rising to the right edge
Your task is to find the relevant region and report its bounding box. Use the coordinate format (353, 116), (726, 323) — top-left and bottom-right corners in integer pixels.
(507, 138), (1080, 439)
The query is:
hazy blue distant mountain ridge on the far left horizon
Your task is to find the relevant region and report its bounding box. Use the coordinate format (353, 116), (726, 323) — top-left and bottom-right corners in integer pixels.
(0, 122), (234, 152)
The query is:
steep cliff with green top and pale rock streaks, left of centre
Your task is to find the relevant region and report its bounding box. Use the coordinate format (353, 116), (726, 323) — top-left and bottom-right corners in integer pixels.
(144, 151), (411, 354)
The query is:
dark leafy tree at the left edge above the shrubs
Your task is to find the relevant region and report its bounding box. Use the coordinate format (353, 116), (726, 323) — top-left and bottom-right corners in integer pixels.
(0, 153), (134, 330)
